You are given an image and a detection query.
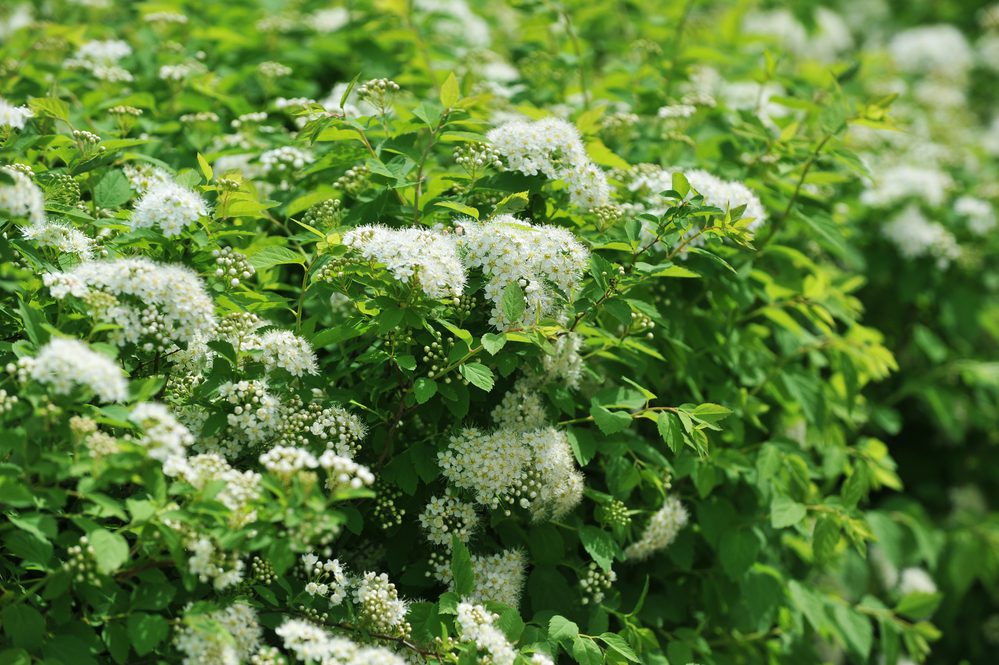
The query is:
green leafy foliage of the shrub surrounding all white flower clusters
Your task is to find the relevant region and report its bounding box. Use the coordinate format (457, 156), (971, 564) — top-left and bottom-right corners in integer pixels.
(0, 0), (999, 664)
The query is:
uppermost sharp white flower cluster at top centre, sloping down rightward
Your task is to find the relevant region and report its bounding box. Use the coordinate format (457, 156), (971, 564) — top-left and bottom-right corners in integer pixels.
(486, 118), (610, 209)
